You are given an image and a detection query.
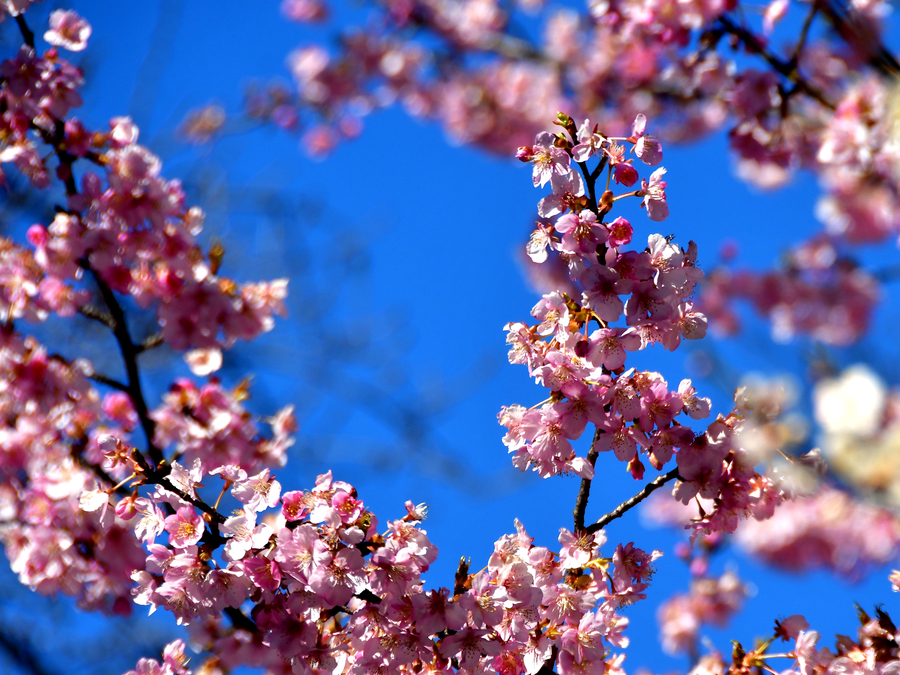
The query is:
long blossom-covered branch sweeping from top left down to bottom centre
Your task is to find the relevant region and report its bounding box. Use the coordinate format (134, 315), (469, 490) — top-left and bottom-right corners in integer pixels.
(0, 6), (684, 675)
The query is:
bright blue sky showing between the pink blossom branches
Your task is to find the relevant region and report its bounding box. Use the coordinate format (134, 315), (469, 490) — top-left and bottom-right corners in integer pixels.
(3, 0), (896, 673)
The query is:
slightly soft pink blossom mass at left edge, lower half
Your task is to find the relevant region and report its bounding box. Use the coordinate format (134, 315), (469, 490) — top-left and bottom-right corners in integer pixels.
(0, 331), (143, 613)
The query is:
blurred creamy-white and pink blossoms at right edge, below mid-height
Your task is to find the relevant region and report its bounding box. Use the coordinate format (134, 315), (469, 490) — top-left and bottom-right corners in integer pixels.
(644, 366), (900, 579)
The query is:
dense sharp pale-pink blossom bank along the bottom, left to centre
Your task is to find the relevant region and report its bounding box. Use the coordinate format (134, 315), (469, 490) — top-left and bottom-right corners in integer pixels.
(96, 464), (660, 674)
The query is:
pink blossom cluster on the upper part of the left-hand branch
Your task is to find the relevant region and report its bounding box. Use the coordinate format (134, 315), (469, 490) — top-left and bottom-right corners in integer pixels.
(0, 12), (287, 350)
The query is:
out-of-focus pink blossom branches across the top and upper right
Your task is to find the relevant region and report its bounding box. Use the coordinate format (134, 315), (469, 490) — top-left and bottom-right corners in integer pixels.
(213, 0), (900, 345)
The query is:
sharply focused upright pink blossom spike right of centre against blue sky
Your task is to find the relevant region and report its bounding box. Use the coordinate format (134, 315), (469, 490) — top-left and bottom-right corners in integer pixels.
(499, 114), (783, 534)
